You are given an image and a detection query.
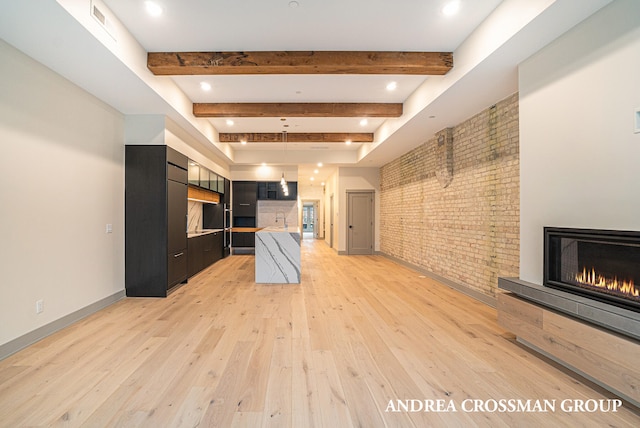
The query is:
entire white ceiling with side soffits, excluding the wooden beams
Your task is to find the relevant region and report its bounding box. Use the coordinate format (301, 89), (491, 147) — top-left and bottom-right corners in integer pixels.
(0, 0), (610, 184)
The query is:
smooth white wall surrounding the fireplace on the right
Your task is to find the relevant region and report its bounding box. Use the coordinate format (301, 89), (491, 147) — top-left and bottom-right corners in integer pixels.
(519, 0), (640, 284)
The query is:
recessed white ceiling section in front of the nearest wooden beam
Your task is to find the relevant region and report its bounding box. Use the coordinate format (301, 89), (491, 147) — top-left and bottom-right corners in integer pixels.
(103, 0), (501, 52)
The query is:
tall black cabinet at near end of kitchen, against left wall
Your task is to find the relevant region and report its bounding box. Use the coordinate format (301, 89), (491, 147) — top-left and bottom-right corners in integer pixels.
(125, 145), (188, 297)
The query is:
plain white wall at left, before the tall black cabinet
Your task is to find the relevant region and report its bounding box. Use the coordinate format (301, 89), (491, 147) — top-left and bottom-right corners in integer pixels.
(0, 41), (124, 345)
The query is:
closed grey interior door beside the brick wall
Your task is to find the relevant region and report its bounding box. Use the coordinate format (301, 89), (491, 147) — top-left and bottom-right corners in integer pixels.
(347, 192), (374, 254)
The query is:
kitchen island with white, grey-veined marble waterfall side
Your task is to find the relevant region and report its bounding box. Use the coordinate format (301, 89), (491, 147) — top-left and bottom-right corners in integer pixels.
(255, 227), (301, 284)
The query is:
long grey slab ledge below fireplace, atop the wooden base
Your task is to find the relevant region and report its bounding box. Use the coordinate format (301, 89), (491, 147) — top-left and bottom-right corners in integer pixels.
(498, 278), (640, 340)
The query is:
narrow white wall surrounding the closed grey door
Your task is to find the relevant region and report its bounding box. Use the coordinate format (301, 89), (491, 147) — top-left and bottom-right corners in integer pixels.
(334, 168), (380, 252)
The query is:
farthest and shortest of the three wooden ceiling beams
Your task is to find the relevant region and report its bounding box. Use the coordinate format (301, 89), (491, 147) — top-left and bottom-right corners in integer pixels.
(219, 132), (373, 143)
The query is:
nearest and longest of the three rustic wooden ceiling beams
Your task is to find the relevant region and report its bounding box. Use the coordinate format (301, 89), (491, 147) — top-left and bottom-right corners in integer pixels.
(147, 51), (453, 76)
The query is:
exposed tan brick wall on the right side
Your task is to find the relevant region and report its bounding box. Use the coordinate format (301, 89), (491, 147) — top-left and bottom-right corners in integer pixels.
(380, 94), (520, 296)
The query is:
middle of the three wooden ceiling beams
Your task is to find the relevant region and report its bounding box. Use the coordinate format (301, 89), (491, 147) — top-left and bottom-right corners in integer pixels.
(193, 103), (402, 117)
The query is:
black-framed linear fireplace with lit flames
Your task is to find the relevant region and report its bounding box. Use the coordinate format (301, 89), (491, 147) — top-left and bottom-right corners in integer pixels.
(544, 227), (640, 312)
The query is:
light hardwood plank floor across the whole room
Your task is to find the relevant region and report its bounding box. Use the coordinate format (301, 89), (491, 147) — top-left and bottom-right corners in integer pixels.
(0, 240), (640, 428)
